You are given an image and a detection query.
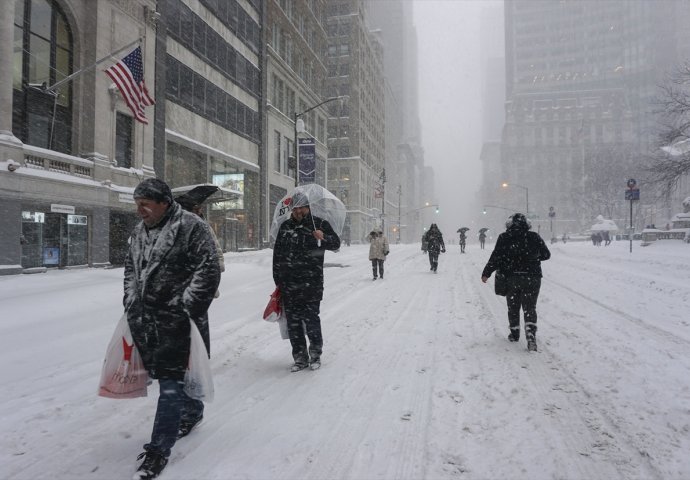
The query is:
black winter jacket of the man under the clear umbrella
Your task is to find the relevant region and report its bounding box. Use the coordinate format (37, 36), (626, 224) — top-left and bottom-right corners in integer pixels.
(273, 214), (340, 303)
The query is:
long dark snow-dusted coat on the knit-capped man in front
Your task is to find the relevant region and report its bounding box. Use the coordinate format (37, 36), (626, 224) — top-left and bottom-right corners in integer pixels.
(123, 203), (220, 380)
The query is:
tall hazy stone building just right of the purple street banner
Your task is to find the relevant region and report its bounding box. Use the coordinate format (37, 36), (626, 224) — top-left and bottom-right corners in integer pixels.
(326, 0), (386, 243)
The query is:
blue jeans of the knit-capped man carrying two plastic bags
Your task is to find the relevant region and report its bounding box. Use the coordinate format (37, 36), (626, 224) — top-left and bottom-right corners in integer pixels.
(144, 380), (204, 458)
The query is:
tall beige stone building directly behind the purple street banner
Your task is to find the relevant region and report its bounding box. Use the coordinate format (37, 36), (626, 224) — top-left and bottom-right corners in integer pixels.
(262, 0), (329, 243)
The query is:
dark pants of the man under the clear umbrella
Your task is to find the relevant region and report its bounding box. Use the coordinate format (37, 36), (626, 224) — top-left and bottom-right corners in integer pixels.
(283, 301), (323, 363)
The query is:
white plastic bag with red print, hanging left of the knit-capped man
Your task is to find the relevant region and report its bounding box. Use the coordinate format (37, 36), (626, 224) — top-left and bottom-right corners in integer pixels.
(98, 314), (149, 398)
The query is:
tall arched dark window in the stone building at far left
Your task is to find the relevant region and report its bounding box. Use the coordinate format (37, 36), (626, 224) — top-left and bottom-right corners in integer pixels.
(12, 0), (73, 153)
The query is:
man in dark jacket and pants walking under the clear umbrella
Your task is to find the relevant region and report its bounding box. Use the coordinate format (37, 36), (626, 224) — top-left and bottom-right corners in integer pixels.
(273, 193), (340, 372)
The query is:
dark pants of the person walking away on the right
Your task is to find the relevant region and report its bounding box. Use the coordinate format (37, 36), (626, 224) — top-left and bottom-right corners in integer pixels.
(506, 275), (541, 339)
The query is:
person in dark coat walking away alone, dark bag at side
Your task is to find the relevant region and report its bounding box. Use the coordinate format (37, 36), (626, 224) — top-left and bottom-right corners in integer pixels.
(482, 213), (551, 351)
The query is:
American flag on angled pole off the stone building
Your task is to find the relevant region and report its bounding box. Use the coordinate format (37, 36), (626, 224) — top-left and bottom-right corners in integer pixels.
(105, 47), (155, 124)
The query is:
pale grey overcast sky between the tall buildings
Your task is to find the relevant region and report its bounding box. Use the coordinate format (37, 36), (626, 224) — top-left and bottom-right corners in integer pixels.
(414, 0), (502, 238)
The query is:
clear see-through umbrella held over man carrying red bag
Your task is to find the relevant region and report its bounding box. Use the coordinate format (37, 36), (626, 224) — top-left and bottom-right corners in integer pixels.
(269, 183), (347, 246)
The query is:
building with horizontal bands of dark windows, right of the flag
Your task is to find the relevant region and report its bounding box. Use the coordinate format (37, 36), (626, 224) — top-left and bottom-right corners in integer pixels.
(160, 0), (263, 251)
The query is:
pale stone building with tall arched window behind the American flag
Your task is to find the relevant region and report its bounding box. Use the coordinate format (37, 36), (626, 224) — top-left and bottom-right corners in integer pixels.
(0, 0), (156, 274)
